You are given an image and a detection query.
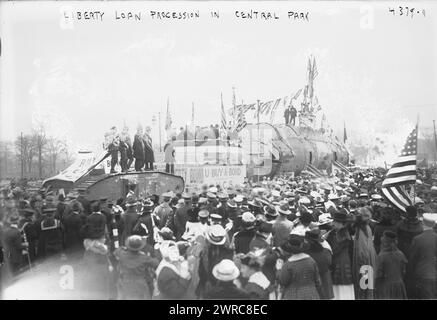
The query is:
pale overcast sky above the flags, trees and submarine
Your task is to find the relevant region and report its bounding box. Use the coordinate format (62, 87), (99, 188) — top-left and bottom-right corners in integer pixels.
(0, 2), (437, 154)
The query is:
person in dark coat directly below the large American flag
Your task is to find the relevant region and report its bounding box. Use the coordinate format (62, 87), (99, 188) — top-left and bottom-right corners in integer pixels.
(396, 206), (423, 257)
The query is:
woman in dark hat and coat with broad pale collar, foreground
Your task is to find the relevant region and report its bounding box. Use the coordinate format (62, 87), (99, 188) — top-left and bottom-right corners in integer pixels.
(279, 234), (322, 300)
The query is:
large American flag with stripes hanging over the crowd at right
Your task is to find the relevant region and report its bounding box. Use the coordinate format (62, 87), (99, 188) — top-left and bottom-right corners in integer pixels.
(381, 125), (418, 212)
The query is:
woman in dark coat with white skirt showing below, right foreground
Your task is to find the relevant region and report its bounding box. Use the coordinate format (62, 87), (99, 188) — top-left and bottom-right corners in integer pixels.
(327, 211), (355, 300)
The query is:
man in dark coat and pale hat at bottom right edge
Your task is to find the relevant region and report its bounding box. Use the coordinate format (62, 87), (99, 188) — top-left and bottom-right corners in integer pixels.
(406, 213), (437, 299)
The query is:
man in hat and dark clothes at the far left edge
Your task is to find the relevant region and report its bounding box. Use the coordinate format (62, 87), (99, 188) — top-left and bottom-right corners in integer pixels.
(2, 215), (29, 275)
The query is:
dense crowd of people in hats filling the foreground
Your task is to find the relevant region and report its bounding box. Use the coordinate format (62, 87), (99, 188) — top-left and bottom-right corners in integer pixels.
(0, 169), (437, 300)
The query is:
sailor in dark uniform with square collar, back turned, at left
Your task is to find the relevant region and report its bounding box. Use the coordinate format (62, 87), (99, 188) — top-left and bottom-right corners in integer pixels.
(38, 208), (64, 258)
